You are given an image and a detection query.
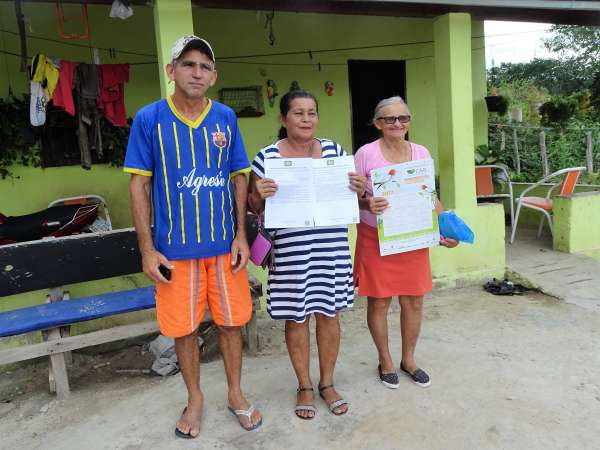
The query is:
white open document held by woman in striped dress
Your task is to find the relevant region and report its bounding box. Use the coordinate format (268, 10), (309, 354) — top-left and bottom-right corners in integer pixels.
(265, 156), (360, 228)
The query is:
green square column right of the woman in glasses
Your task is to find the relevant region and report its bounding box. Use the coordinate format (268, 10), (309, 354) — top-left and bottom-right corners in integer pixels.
(434, 13), (476, 211)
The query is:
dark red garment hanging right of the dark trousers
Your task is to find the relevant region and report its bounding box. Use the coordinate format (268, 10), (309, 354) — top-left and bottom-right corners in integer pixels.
(98, 64), (129, 127)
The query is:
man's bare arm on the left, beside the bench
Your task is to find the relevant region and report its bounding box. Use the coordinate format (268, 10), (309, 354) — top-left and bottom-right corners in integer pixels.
(129, 174), (172, 283)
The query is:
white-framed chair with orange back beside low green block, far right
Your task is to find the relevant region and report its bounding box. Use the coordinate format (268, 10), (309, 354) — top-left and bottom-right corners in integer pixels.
(510, 167), (585, 244)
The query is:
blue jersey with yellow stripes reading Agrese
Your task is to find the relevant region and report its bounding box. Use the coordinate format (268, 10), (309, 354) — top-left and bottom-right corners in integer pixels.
(124, 98), (250, 259)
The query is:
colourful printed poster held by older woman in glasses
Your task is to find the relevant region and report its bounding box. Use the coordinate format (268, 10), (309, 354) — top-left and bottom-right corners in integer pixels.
(371, 159), (440, 256)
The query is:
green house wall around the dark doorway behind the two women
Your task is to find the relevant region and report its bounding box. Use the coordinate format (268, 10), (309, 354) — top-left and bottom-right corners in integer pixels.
(194, 8), (436, 155)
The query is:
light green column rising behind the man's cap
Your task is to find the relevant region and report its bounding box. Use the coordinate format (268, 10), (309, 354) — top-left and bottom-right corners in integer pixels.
(154, 0), (194, 98)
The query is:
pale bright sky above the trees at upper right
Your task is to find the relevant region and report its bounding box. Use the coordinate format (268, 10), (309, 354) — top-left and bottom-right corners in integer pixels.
(485, 20), (553, 69)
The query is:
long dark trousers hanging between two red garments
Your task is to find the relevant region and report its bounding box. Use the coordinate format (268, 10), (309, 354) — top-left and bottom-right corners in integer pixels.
(73, 64), (103, 170)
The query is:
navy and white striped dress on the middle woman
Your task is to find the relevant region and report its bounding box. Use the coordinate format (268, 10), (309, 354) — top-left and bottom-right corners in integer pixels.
(252, 139), (354, 323)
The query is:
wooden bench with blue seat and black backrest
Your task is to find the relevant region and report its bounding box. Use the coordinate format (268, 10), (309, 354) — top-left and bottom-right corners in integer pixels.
(0, 228), (262, 400)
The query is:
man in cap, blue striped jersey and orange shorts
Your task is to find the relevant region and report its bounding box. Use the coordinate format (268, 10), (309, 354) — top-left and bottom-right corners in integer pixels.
(124, 36), (262, 438)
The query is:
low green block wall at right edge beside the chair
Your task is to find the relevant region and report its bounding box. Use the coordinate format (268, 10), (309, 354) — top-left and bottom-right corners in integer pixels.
(553, 192), (600, 253)
